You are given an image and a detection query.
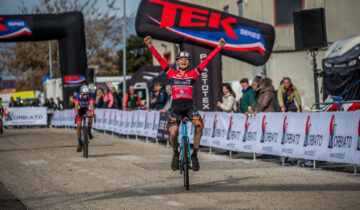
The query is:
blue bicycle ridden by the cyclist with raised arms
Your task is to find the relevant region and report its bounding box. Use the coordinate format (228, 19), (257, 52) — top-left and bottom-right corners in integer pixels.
(179, 117), (192, 190)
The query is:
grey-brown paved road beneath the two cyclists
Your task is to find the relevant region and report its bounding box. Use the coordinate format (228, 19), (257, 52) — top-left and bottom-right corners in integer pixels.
(0, 128), (360, 209)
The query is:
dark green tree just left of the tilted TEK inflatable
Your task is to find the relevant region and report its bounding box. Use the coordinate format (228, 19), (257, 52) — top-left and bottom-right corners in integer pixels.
(117, 35), (153, 75)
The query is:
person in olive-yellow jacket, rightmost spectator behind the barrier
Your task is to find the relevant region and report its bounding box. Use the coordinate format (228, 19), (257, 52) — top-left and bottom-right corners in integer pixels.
(277, 77), (302, 112)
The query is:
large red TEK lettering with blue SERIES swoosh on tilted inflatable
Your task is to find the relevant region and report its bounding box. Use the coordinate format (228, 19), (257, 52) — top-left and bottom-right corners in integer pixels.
(148, 0), (266, 55)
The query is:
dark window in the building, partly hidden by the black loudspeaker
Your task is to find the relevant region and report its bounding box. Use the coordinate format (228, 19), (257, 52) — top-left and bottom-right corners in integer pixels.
(274, 0), (304, 26)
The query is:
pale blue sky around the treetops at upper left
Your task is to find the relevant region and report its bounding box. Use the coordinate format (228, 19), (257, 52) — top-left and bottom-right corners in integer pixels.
(0, 0), (141, 79)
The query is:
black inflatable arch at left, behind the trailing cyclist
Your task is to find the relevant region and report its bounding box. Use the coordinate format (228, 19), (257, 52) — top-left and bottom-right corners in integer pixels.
(0, 12), (87, 104)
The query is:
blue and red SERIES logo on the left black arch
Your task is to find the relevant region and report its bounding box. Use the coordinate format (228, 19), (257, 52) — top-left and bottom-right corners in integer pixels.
(0, 17), (31, 40)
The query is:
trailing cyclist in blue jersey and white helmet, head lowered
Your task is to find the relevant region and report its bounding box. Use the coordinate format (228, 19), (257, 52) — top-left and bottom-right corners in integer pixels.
(75, 85), (94, 152)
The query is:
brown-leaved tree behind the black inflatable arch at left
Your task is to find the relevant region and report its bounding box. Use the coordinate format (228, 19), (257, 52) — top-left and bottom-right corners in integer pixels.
(0, 0), (122, 90)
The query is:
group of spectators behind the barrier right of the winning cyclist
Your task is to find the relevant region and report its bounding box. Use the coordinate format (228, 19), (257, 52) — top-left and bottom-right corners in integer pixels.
(216, 76), (302, 115)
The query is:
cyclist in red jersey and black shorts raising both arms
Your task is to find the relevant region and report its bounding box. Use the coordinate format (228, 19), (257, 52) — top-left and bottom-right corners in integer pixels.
(144, 36), (225, 171)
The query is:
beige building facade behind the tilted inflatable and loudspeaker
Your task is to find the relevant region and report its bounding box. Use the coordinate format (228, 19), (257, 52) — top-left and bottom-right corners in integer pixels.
(153, 0), (360, 108)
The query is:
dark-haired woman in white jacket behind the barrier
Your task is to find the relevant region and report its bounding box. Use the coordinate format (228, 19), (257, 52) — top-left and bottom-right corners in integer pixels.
(216, 83), (236, 112)
